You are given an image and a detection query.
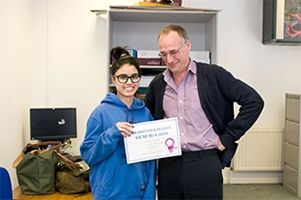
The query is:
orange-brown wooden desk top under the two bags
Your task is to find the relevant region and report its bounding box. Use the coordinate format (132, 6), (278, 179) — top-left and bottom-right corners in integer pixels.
(13, 186), (92, 200)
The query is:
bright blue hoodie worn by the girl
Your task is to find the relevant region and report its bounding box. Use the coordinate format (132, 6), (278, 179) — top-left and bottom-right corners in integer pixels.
(80, 93), (156, 200)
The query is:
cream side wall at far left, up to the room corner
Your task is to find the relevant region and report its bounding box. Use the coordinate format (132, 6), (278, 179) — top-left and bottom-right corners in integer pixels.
(0, 0), (34, 189)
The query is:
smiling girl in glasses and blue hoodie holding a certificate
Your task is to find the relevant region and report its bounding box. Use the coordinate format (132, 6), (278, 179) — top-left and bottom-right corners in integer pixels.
(80, 47), (156, 200)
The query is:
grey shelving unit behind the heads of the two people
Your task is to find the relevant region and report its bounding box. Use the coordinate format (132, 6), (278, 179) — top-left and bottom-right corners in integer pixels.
(91, 6), (219, 94)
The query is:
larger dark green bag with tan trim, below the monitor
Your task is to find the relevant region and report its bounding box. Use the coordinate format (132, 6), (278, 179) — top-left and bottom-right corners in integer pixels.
(13, 142), (62, 194)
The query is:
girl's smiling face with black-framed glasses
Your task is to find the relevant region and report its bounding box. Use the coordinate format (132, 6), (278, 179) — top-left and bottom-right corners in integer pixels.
(112, 64), (140, 99)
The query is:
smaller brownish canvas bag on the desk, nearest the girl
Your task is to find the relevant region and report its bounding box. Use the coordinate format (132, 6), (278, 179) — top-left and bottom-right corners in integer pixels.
(55, 151), (91, 194)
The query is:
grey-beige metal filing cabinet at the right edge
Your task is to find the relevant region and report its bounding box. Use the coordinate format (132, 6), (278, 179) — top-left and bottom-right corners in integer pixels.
(283, 94), (301, 197)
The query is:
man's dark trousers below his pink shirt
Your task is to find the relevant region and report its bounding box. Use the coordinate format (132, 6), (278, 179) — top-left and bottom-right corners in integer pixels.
(158, 149), (223, 199)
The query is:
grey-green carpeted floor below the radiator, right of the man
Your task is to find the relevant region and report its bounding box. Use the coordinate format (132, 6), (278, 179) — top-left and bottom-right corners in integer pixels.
(224, 184), (301, 200)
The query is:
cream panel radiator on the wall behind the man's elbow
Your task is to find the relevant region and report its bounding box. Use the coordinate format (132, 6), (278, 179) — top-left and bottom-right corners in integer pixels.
(231, 129), (283, 171)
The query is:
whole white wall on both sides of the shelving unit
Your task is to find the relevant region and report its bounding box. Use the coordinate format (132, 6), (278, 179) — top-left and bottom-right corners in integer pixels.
(0, 0), (301, 190)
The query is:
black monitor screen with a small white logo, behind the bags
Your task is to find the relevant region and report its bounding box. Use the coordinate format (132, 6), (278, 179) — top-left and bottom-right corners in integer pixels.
(30, 108), (77, 141)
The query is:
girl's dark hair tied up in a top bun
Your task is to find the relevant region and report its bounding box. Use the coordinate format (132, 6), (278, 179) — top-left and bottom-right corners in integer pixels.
(110, 46), (141, 75)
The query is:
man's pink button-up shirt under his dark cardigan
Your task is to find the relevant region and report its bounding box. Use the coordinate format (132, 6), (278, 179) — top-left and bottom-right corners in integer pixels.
(163, 61), (218, 151)
